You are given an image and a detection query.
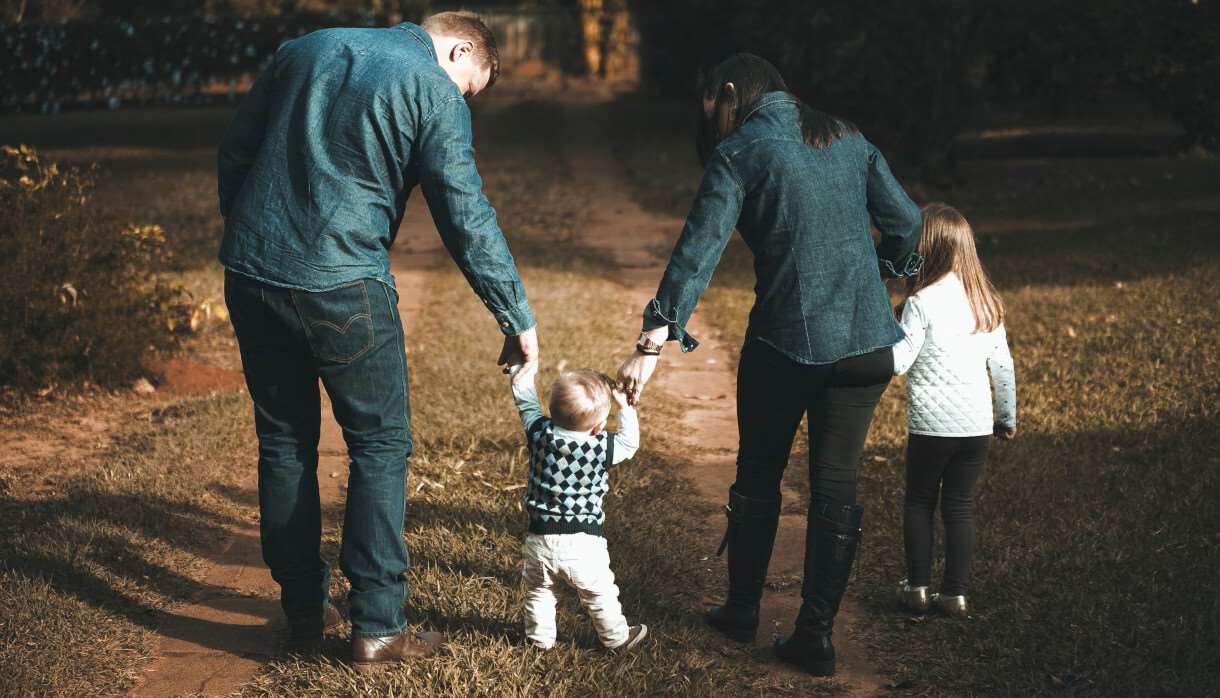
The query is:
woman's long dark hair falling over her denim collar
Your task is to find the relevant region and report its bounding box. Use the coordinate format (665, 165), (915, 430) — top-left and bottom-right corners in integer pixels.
(695, 54), (858, 165)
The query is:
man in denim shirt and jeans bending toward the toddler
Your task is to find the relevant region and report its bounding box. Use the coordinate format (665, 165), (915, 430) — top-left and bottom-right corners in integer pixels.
(218, 12), (538, 665)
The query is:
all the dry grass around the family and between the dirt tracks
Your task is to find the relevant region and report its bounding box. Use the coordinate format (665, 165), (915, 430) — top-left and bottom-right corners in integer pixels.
(0, 88), (1220, 696)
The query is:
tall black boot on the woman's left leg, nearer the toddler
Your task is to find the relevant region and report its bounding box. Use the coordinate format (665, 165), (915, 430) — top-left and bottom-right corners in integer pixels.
(706, 487), (780, 642)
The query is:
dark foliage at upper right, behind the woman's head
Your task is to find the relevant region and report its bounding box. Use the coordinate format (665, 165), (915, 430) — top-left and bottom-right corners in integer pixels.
(632, 0), (1220, 166)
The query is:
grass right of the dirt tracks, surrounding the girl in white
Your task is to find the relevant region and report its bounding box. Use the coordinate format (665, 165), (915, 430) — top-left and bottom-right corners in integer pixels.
(617, 93), (1220, 696)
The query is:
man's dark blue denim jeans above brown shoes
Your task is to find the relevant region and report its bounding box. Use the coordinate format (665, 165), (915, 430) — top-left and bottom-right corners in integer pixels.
(224, 272), (411, 636)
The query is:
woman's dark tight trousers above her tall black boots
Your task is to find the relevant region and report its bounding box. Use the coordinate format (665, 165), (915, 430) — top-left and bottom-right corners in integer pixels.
(734, 340), (894, 506)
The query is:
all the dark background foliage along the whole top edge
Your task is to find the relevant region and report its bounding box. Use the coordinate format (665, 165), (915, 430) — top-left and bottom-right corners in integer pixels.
(0, 0), (1220, 168)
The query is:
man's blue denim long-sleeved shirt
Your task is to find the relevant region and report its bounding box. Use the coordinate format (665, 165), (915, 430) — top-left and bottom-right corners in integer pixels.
(218, 23), (534, 334)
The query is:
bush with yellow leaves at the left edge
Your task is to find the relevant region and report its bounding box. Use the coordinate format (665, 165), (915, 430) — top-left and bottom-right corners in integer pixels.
(0, 145), (187, 389)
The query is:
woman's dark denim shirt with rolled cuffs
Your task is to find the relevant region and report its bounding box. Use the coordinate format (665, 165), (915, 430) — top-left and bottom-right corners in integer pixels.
(644, 93), (920, 364)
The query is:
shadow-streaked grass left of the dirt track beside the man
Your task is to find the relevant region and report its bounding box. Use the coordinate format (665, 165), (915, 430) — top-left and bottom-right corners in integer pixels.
(0, 394), (254, 696)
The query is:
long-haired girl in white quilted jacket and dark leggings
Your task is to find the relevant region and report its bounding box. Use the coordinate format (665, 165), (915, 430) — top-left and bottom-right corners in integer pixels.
(894, 204), (1016, 617)
